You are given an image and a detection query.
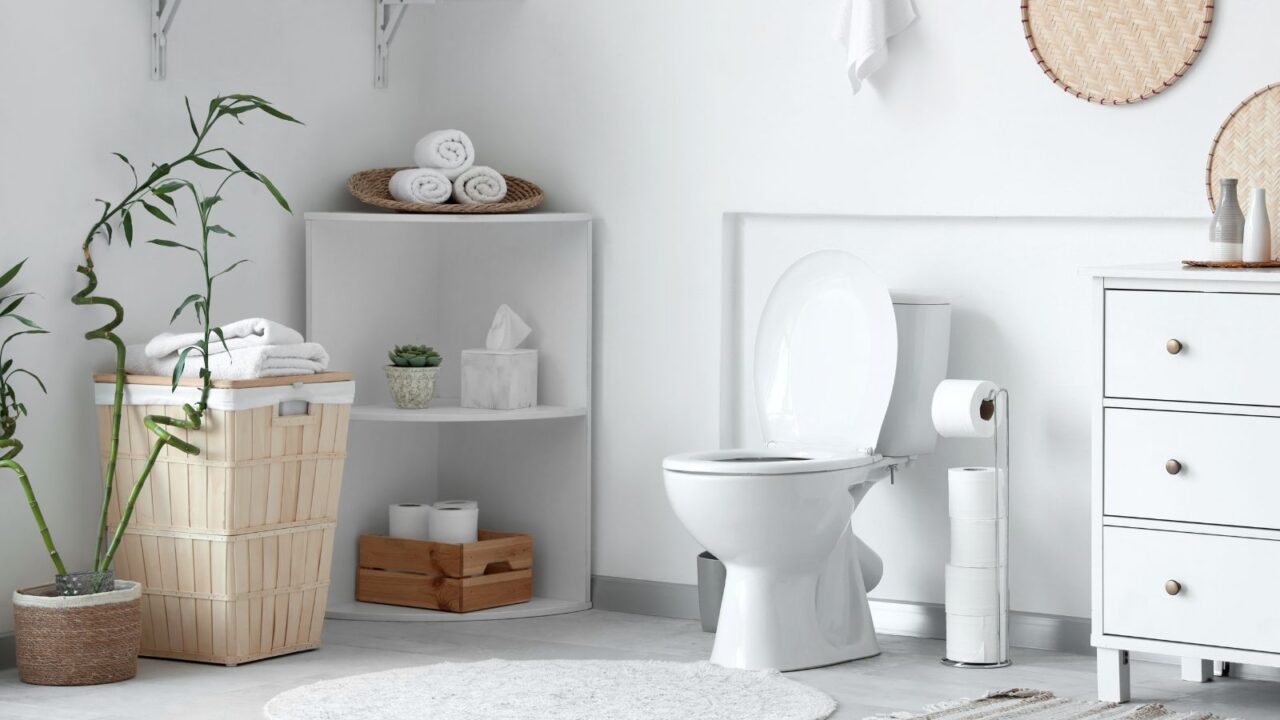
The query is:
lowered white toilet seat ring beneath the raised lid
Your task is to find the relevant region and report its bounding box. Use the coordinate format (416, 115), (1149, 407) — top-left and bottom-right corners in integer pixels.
(662, 447), (877, 475)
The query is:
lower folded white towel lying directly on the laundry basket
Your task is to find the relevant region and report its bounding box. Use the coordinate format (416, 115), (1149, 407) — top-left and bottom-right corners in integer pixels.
(124, 342), (329, 380)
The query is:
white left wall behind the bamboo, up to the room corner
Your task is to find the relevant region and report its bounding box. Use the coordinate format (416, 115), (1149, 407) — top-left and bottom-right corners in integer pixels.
(0, 0), (440, 632)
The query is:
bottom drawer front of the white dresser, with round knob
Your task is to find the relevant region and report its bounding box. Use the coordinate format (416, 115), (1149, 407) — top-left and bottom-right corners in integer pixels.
(1102, 520), (1280, 652)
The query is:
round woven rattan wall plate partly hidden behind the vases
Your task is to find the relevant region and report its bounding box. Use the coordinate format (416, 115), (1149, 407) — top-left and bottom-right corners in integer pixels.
(1204, 82), (1280, 213)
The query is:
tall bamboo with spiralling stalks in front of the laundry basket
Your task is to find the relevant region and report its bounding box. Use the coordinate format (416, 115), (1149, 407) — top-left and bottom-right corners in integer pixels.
(72, 95), (298, 573)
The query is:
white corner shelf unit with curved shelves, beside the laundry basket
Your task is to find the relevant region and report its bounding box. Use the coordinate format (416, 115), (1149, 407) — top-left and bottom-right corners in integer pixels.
(306, 213), (591, 621)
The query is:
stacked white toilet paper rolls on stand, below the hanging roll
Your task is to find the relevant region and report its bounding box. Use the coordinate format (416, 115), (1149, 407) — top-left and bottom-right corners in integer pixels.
(946, 468), (1009, 665)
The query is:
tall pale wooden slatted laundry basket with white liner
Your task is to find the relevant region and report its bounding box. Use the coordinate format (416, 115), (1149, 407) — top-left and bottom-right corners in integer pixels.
(96, 373), (355, 665)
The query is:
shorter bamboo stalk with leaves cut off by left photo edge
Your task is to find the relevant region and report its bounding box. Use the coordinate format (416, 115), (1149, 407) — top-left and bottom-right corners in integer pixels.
(0, 260), (67, 575)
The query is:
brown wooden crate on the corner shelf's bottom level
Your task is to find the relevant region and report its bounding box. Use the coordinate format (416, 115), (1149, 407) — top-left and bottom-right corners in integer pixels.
(356, 530), (534, 612)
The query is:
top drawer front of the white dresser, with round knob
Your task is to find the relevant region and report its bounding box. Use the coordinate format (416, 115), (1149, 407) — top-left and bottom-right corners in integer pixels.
(1105, 290), (1280, 406)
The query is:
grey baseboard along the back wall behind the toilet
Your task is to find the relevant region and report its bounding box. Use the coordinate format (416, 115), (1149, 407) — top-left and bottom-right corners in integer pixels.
(591, 575), (1093, 653)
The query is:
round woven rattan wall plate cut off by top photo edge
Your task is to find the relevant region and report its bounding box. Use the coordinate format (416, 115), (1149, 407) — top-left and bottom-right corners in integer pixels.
(1021, 0), (1213, 105)
